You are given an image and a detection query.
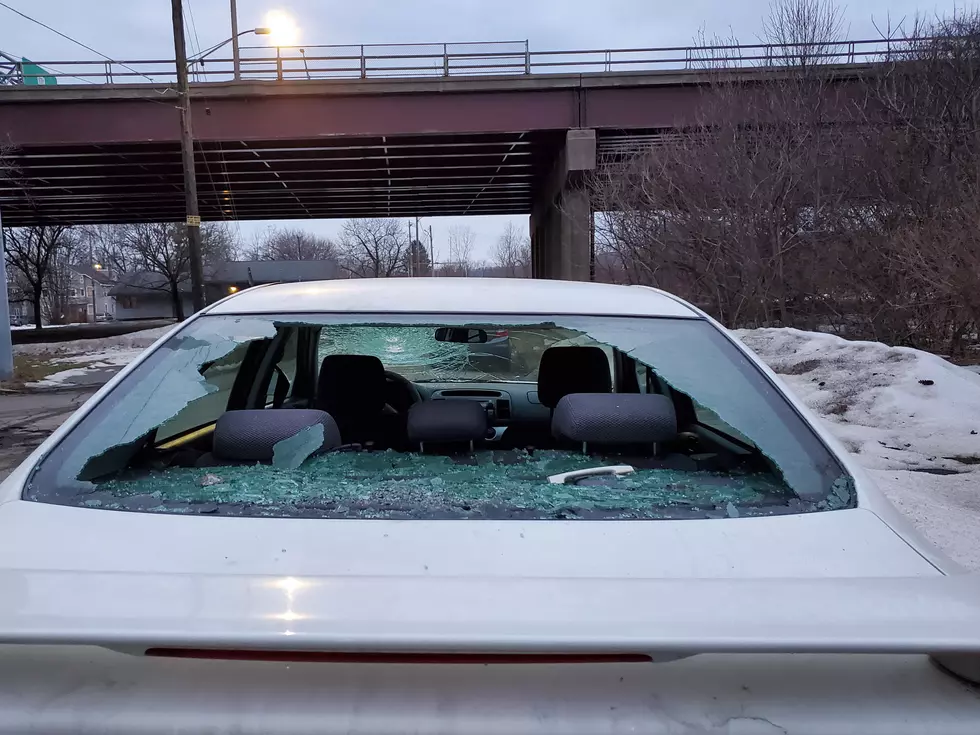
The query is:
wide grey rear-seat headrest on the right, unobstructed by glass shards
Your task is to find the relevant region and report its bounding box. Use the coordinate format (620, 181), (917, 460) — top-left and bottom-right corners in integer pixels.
(551, 393), (677, 444)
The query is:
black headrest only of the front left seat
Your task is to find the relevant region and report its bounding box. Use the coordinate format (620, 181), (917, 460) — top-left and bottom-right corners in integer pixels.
(316, 355), (386, 416)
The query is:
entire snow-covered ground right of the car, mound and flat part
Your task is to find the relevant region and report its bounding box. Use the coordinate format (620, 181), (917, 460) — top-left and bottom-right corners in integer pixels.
(735, 329), (980, 570)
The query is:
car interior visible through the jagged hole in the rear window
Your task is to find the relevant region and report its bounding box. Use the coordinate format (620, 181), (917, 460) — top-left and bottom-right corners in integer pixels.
(113, 325), (772, 482)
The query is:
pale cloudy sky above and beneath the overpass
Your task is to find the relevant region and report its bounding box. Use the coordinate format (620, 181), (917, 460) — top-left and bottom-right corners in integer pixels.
(0, 0), (964, 260)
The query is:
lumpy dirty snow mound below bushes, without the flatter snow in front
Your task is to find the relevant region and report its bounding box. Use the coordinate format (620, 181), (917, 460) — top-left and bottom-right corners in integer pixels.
(736, 329), (980, 472)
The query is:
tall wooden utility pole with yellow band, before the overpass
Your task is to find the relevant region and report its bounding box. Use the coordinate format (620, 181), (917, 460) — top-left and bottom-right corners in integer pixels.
(170, 0), (207, 311)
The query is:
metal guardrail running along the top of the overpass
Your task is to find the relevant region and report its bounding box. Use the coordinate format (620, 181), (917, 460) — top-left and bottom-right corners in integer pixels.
(0, 38), (932, 85)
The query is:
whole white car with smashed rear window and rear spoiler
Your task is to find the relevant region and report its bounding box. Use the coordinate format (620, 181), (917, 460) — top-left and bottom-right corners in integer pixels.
(0, 279), (980, 735)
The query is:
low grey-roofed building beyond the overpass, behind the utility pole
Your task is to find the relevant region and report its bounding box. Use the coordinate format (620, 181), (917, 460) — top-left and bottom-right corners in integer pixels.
(109, 260), (337, 320)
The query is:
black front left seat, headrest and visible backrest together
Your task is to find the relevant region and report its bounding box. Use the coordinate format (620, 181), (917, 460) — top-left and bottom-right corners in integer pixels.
(315, 355), (401, 448)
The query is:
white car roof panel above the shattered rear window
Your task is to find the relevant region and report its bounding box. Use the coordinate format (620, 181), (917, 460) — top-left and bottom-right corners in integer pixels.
(208, 278), (701, 318)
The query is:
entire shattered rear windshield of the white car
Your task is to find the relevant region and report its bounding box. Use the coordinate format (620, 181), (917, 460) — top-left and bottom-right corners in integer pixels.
(24, 314), (854, 520)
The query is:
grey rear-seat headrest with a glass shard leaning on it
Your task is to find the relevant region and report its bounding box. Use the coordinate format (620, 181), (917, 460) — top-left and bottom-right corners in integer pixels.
(211, 408), (341, 462)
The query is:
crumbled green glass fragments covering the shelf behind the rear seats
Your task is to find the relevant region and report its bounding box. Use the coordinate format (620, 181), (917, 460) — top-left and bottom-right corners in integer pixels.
(86, 450), (804, 520)
